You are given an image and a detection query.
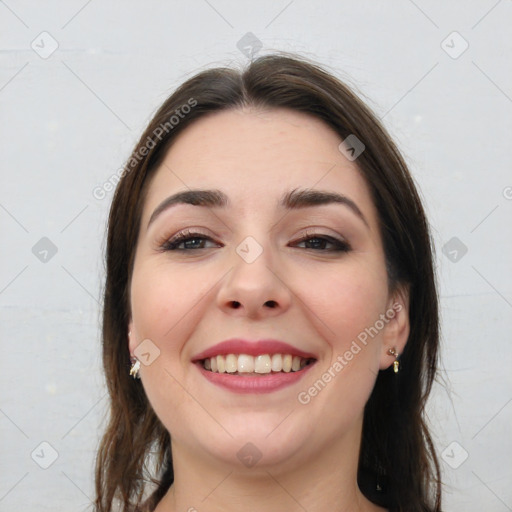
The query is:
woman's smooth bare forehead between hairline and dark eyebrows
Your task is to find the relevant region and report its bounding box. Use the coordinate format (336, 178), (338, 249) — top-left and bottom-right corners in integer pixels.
(143, 109), (375, 222)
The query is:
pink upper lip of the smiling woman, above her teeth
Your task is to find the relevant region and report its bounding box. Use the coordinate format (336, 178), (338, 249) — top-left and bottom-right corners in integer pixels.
(192, 338), (315, 362)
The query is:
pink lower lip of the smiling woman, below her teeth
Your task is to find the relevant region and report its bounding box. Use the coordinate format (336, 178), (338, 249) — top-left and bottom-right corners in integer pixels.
(196, 363), (315, 393)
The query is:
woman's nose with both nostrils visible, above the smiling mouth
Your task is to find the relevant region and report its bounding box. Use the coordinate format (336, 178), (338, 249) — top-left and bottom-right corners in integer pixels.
(217, 242), (292, 319)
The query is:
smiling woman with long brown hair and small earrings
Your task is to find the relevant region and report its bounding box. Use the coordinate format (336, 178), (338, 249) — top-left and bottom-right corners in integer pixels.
(96, 54), (440, 512)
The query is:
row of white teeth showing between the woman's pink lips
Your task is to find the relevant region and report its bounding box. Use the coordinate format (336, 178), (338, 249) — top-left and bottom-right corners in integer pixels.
(199, 354), (316, 377)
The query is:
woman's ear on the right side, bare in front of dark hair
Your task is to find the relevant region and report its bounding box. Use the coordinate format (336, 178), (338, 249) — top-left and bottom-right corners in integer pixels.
(380, 285), (410, 370)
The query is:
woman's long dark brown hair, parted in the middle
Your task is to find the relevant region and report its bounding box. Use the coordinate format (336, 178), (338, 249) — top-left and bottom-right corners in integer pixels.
(95, 53), (441, 512)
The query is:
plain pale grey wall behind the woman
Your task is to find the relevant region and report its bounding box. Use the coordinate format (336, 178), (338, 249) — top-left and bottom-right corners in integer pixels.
(0, 0), (512, 512)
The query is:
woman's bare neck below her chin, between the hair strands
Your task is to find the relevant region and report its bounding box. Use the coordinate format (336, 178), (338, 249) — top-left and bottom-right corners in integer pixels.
(155, 422), (383, 512)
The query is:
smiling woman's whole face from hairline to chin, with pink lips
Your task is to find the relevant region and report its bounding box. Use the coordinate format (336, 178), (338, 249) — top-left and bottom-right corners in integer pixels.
(129, 109), (408, 469)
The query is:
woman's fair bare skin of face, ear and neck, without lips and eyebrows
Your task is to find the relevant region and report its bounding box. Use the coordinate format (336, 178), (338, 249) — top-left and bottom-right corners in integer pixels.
(128, 109), (409, 512)
